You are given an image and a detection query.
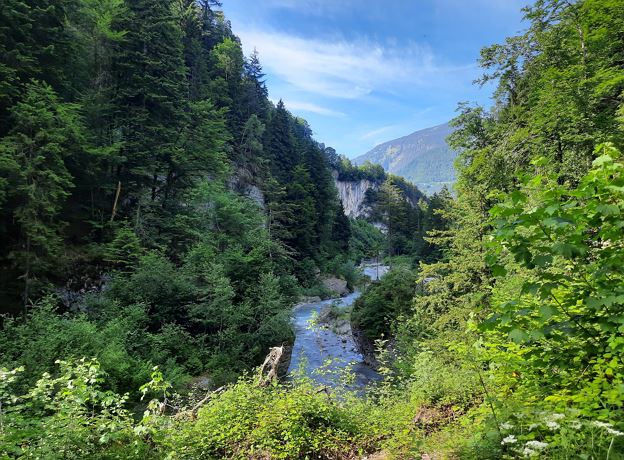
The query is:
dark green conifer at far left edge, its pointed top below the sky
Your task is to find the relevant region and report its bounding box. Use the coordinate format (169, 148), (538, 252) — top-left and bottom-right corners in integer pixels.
(0, 81), (83, 306)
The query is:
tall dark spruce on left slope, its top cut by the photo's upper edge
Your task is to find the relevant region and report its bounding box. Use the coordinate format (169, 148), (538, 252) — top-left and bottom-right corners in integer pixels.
(115, 0), (187, 212)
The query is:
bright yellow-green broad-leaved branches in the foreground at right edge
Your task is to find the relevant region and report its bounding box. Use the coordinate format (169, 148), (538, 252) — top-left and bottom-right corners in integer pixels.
(484, 145), (624, 420)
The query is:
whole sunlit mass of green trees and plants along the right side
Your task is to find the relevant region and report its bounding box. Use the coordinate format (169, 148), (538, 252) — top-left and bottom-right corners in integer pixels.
(380, 0), (623, 458)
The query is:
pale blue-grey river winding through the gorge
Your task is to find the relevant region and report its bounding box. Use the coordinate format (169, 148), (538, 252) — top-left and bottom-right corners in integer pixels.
(288, 264), (388, 390)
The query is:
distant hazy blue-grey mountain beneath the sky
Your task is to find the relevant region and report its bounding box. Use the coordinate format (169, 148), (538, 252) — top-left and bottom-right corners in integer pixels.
(354, 123), (457, 194)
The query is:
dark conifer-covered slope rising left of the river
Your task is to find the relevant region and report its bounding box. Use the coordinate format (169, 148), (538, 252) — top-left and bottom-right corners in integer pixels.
(0, 0), (361, 391)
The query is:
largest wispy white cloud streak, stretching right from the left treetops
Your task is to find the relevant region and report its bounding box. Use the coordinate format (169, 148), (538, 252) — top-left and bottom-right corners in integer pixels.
(238, 30), (461, 99)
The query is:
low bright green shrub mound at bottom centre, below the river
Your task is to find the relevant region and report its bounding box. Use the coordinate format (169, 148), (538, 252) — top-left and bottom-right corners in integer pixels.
(169, 382), (378, 458)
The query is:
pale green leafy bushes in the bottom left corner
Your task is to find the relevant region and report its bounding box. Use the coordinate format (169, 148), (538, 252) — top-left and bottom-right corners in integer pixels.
(0, 359), (150, 458)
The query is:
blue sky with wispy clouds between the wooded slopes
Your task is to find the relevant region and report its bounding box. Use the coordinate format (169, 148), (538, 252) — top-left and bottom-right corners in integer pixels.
(223, 0), (528, 158)
